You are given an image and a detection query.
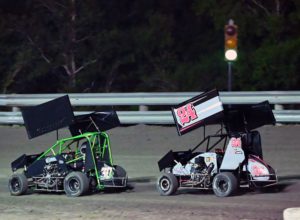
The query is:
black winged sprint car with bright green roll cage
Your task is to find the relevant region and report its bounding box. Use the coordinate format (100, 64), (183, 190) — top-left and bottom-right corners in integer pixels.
(9, 95), (128, 197)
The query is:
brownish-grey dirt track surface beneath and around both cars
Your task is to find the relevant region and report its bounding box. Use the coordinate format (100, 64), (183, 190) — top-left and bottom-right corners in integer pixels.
(0, 125), (300, 220)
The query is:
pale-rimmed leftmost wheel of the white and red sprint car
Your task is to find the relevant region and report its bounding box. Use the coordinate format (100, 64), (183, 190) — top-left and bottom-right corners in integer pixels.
(156, 173), (178, 196)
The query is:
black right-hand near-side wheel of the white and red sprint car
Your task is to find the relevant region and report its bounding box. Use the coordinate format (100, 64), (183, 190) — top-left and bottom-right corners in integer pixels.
(213, 172), (238, 197)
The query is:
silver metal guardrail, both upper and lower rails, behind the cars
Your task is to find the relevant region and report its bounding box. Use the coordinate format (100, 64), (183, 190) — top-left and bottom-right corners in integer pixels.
(0, 91), (300, 124)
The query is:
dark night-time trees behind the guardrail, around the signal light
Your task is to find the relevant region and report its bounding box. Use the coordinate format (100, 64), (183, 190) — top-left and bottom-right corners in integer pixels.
(0, 0), (300, 93)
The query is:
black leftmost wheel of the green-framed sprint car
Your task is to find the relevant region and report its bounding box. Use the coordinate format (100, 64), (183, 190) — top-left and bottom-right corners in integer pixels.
(8, 173), (28, 196)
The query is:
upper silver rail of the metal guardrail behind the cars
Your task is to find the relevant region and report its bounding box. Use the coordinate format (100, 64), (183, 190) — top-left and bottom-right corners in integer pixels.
(0, 91), (300, 107)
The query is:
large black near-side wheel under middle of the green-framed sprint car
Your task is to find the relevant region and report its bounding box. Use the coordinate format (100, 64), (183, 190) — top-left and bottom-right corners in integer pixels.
(64, 172), (89, 197)
